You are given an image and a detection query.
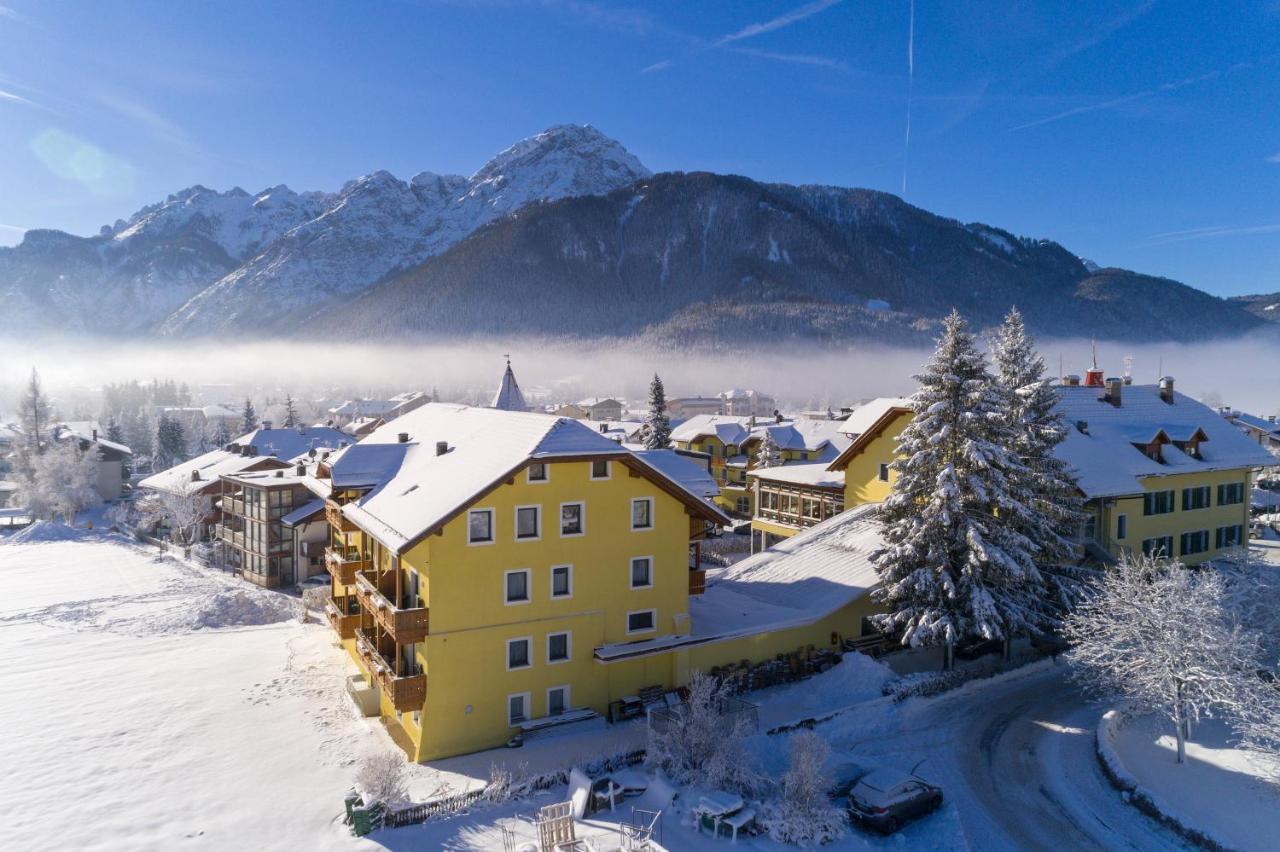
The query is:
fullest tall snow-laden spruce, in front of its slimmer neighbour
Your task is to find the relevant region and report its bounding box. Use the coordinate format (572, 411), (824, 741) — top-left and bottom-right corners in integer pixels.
(873, 311), (1043, 668)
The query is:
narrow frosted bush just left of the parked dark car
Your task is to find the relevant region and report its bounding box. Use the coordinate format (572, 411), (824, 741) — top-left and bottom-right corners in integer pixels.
(763, 730), (849, 846)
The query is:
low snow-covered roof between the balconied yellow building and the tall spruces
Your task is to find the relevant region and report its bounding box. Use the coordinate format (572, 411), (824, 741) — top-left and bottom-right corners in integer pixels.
(595, 503), (883, 661)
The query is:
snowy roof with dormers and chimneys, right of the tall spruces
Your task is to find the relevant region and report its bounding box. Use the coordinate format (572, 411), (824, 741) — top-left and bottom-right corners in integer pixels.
(1055, 385), (1275, 498)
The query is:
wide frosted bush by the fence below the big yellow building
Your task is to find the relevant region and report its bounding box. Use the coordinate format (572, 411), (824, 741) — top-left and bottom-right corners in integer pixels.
(645, 672), (765, 794)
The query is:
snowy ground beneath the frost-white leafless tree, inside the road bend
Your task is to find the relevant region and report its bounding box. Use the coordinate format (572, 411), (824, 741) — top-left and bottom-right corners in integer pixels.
(1115, 716), (1280, 849)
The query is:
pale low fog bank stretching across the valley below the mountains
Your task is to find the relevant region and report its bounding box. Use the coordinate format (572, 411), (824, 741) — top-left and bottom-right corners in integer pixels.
(0, 335), (1280, 416)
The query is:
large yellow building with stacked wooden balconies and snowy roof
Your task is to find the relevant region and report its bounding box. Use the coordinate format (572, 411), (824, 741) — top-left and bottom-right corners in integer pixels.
(320, 404), (728, 760)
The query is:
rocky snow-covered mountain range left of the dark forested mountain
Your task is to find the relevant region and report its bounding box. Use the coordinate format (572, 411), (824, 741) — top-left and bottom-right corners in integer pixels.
(0, 125), (650, 335)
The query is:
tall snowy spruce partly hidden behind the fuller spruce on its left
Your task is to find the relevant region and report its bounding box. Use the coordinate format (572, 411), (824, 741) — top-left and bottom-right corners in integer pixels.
(992, 308), (1091, 627)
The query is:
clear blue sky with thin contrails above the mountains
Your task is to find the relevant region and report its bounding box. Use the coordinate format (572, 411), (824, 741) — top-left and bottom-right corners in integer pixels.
(0, 0), (1280, 294)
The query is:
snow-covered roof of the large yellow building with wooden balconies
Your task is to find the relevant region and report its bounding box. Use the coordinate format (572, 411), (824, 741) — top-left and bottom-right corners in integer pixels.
(330, 403), (727, 551)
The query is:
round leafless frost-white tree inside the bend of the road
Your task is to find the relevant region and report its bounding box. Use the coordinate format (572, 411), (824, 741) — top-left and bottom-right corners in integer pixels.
(1064, 555), (1258, 762)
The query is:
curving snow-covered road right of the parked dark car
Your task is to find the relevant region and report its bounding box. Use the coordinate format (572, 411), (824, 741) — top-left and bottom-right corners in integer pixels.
(836, 664), (1188, 851)
